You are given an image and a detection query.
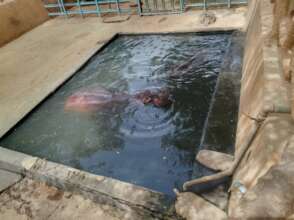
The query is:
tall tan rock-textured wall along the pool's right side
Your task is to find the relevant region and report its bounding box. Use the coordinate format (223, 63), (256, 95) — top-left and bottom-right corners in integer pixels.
(228, 0), (294, 219)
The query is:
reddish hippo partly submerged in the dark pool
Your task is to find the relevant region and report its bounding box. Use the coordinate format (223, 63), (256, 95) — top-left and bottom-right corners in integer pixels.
(64, 85), (172, 112)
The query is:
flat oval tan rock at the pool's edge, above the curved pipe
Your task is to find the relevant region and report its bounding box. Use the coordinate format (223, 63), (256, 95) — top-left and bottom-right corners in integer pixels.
(196, 150), (234, 171)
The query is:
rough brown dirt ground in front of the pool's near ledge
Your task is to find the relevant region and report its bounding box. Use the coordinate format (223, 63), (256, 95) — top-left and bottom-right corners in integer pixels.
(0, 178), (163, 220)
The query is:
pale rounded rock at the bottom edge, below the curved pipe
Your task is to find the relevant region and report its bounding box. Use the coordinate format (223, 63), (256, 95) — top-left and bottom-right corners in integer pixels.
(175, 192), (227, 220)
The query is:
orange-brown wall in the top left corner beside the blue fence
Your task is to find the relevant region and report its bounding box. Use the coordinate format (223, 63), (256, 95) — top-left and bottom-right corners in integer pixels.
(0, 0), (49, 47)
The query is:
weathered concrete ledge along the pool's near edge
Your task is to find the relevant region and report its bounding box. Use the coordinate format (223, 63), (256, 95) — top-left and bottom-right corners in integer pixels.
(0, 147), (173, 213)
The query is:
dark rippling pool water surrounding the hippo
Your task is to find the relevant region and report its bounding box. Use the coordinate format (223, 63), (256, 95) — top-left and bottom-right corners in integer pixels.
(0, 33), (230, 194)
